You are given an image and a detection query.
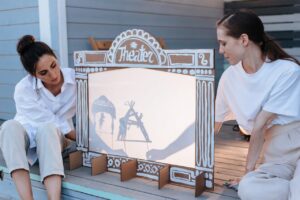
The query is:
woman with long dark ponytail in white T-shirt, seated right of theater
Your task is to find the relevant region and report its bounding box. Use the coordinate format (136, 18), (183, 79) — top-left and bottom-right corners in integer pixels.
(215, 10), (300, 200)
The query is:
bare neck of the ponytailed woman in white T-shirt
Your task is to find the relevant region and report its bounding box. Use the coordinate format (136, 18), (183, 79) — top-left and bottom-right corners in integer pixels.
(242, 45), (265, 74)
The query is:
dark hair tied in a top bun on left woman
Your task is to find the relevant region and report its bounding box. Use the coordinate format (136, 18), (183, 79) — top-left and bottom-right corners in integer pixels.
(17, 35), (56, 76)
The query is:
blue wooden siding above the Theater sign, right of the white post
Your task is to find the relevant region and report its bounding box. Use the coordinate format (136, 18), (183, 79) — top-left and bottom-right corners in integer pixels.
(66, 0), (224, 77)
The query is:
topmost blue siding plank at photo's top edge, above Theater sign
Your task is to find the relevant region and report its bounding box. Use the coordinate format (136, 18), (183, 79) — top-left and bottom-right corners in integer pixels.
(66, 0), (223, 18)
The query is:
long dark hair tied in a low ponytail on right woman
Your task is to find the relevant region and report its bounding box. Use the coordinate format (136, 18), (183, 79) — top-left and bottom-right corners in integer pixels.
(217, 10), (300, 65)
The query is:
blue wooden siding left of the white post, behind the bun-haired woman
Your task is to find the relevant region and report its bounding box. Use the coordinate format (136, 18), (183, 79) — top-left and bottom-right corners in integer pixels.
(0, 0), (39, 119)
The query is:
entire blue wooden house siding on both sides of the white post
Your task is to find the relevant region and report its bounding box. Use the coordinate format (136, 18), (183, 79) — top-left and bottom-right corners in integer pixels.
(0, 0), (224, 119)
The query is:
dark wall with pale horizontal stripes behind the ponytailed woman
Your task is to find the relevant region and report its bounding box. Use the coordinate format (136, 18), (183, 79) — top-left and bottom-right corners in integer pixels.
(225, 0), (300, 60)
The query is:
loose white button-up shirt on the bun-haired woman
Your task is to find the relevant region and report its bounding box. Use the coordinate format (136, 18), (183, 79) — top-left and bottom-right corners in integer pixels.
(14, 68), (76, 164)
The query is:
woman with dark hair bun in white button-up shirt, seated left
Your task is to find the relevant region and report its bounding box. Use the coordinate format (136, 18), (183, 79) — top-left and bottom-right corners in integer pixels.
(0, 35), (76, 200)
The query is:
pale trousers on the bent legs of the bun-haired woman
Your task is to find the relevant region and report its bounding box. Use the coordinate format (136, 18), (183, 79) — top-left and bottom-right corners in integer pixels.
(0, 120), (64, 181)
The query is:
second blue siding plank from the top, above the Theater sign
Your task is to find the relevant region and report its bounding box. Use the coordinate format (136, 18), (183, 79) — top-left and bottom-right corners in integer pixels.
(67, 7), (217, 28)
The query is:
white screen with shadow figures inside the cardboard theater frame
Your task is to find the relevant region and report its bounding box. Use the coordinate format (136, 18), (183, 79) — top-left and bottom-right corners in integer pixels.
(88, 68), (196, 168)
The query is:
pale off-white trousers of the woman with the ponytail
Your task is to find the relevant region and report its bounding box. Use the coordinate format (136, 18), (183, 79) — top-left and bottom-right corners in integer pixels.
(238, 122), (300, 200)
